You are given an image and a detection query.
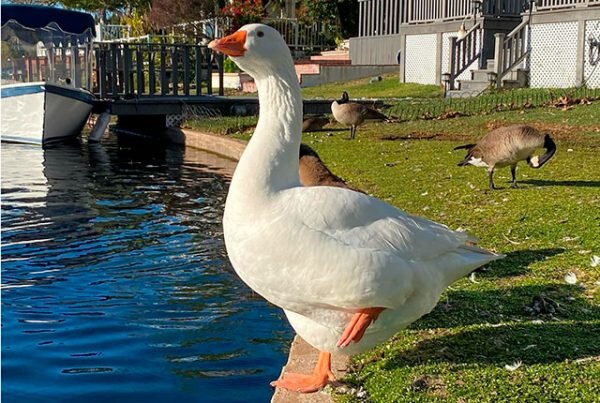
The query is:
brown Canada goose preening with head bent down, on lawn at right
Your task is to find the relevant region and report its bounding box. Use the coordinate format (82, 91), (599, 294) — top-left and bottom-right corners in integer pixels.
(454, 125), (556, 189)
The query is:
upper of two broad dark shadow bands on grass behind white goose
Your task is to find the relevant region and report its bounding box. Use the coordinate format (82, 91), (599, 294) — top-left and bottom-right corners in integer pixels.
(410, 284), (600, 330)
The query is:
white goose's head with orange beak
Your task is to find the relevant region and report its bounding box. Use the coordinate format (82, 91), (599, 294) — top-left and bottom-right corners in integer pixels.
(208, 24), (294, 79)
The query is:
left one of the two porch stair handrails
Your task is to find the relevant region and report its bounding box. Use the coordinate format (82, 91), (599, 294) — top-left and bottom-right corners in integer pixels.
(448, 22), (483, 89)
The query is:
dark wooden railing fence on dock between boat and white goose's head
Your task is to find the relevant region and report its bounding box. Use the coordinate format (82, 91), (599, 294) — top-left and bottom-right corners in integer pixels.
(93, 42), (223, 98)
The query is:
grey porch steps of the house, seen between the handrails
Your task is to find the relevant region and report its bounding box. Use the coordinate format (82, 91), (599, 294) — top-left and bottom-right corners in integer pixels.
(446, 59), (529, 98)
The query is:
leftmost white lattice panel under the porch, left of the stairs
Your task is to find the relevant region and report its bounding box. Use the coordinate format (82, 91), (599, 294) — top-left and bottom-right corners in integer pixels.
(404, 34), (437, 84)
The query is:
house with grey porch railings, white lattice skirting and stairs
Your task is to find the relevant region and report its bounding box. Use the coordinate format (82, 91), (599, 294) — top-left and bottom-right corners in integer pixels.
(350, 0), (600, 96)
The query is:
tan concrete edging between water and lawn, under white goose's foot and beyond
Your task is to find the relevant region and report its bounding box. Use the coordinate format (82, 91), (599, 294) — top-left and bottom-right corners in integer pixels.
(167, 128), (350, 403)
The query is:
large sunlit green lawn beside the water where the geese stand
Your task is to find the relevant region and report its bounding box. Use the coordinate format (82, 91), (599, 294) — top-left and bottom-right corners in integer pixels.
(185, 102), (600, 402)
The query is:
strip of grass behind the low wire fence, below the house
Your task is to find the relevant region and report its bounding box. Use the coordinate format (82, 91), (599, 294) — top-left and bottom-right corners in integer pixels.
(302, 73), (443, 99)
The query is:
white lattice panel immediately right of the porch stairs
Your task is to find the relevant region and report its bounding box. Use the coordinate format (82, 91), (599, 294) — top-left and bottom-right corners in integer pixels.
(530, 21), (578, 88)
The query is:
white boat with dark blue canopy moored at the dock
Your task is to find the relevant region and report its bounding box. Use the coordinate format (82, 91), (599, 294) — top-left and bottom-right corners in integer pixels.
(0, 4), (95, 145)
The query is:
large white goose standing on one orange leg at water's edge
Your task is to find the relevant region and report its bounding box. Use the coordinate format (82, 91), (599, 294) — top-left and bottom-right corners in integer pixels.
(209, 24), (501, 392)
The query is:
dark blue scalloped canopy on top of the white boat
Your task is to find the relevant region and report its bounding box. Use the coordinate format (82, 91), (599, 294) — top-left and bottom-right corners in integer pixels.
(2, 4), (96, 36)
